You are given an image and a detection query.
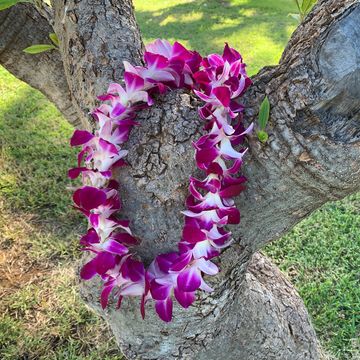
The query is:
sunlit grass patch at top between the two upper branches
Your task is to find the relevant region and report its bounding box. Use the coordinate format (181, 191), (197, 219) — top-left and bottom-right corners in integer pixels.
(134, 0), (296, 74)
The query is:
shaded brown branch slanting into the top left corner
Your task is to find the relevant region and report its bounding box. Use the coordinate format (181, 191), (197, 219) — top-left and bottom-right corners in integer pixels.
(0, 4), (80, 126)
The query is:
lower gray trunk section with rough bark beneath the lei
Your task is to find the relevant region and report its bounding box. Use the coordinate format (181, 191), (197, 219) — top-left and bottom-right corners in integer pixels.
(81, 250), (319, 360)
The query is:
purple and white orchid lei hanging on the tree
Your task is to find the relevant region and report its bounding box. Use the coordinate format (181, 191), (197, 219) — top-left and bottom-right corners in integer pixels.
(69, 39), (253, 322)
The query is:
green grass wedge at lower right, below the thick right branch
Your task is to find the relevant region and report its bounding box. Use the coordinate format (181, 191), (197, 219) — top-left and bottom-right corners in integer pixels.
(265, 193), (360, 359)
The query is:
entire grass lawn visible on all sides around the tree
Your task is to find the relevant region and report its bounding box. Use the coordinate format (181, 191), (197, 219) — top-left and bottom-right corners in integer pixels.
(0, 0), (360, 360)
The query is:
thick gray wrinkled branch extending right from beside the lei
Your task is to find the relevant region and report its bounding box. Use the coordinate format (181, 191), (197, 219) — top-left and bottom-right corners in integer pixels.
(239, 0), (360, 253)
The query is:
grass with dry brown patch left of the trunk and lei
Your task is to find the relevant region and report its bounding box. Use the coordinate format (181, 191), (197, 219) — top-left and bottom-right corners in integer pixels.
(0, 68), (121, 360)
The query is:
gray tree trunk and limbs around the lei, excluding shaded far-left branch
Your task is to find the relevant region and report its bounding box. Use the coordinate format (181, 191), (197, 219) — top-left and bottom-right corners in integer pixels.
(0, 0), (360, 360)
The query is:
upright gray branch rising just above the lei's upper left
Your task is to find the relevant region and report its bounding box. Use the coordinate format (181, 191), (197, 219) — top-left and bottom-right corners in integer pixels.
(52, 0), (143, 125)
